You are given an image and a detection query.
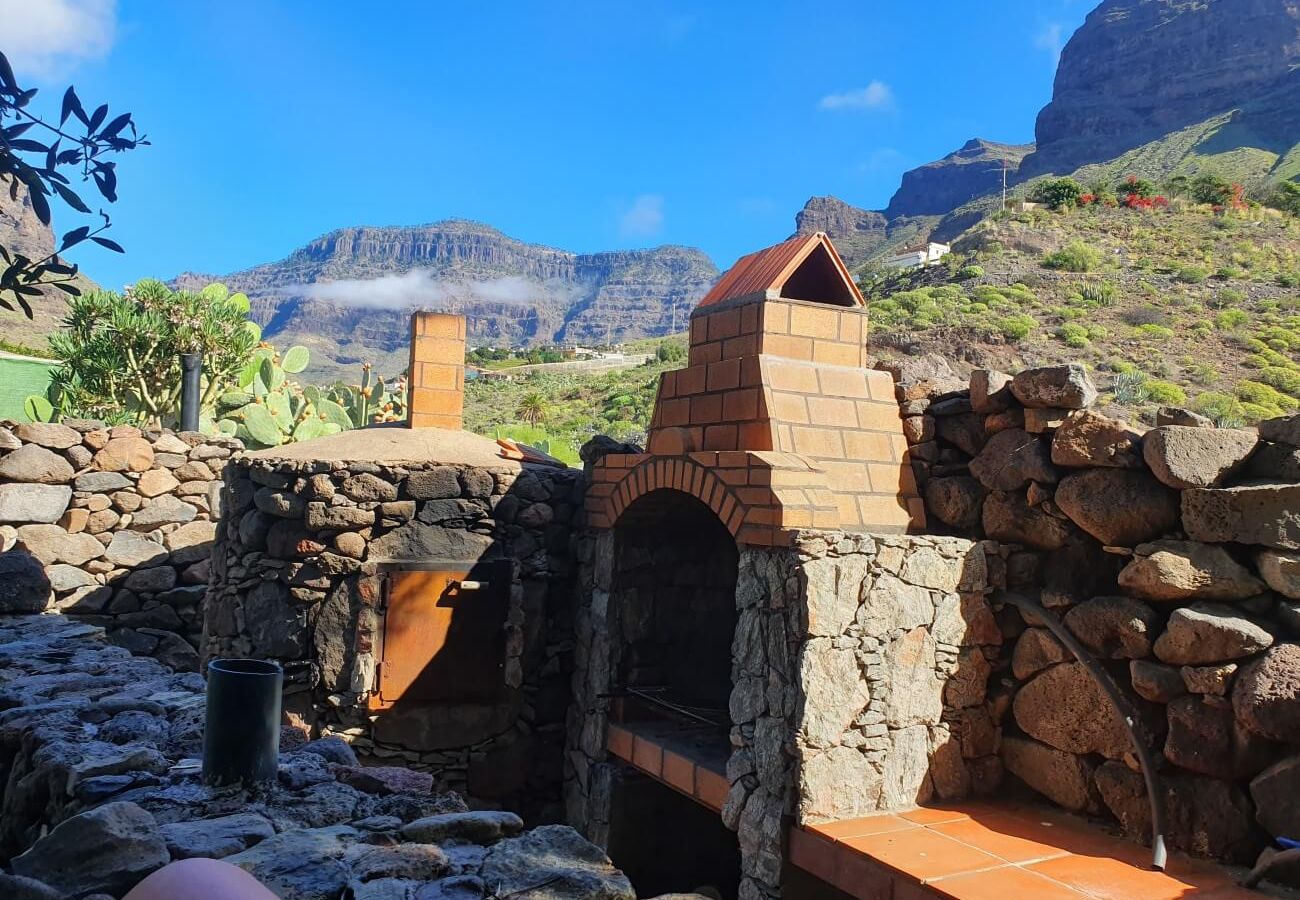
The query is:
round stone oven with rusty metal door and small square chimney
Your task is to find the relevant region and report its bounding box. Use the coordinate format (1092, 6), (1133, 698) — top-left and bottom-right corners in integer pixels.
(204, 312), (581, 821)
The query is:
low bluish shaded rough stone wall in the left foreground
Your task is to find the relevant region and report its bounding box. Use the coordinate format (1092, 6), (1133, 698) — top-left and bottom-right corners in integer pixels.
(0, 615), (636, 900)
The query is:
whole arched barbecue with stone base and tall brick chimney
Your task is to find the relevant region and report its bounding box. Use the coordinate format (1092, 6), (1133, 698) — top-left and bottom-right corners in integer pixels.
(566, 233), (1000, 900)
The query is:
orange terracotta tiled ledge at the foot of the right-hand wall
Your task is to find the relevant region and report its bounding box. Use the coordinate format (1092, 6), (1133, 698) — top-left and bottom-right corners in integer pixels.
(789, 804), (1261, 900)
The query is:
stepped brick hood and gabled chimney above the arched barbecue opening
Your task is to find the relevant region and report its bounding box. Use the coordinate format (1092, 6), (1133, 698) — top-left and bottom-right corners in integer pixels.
(588, 233), (924, 545)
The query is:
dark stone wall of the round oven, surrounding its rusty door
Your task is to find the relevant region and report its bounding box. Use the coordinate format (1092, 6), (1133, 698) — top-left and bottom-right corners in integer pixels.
(204, 451), (582, 821)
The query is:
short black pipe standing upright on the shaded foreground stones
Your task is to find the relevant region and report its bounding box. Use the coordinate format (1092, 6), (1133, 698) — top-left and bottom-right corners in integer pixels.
(203, 659), (285, 786)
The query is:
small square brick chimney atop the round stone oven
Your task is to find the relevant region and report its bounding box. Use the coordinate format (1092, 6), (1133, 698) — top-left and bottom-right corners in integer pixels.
(407, 312), (465, 430)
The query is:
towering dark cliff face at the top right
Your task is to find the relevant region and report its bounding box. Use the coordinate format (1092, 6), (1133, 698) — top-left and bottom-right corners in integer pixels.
(1023, 0), (1300, 174)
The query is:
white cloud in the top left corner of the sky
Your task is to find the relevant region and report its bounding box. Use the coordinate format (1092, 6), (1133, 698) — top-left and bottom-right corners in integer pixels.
(0, 0), (117, 79)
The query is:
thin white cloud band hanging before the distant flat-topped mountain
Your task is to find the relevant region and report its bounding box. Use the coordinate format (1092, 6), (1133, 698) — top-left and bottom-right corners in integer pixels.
(295, 269), (553, 310)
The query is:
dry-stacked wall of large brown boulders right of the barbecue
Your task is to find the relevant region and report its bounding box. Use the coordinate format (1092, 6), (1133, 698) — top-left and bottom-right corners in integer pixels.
(896, 365), (1300, 861)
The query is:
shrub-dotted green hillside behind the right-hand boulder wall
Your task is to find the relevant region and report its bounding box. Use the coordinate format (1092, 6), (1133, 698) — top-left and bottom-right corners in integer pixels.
(867, 207), (1300, 420)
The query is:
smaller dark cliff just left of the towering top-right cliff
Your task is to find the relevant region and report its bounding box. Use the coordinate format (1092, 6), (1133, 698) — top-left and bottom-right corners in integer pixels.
(885, 138), (1034, 218)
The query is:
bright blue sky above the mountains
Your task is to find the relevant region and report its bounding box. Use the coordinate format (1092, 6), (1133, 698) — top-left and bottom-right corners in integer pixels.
(0, 0), (1095, 286)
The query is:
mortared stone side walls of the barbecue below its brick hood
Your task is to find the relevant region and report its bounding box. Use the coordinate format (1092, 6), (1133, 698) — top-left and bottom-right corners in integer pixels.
(566, 520), (1001, 900)
